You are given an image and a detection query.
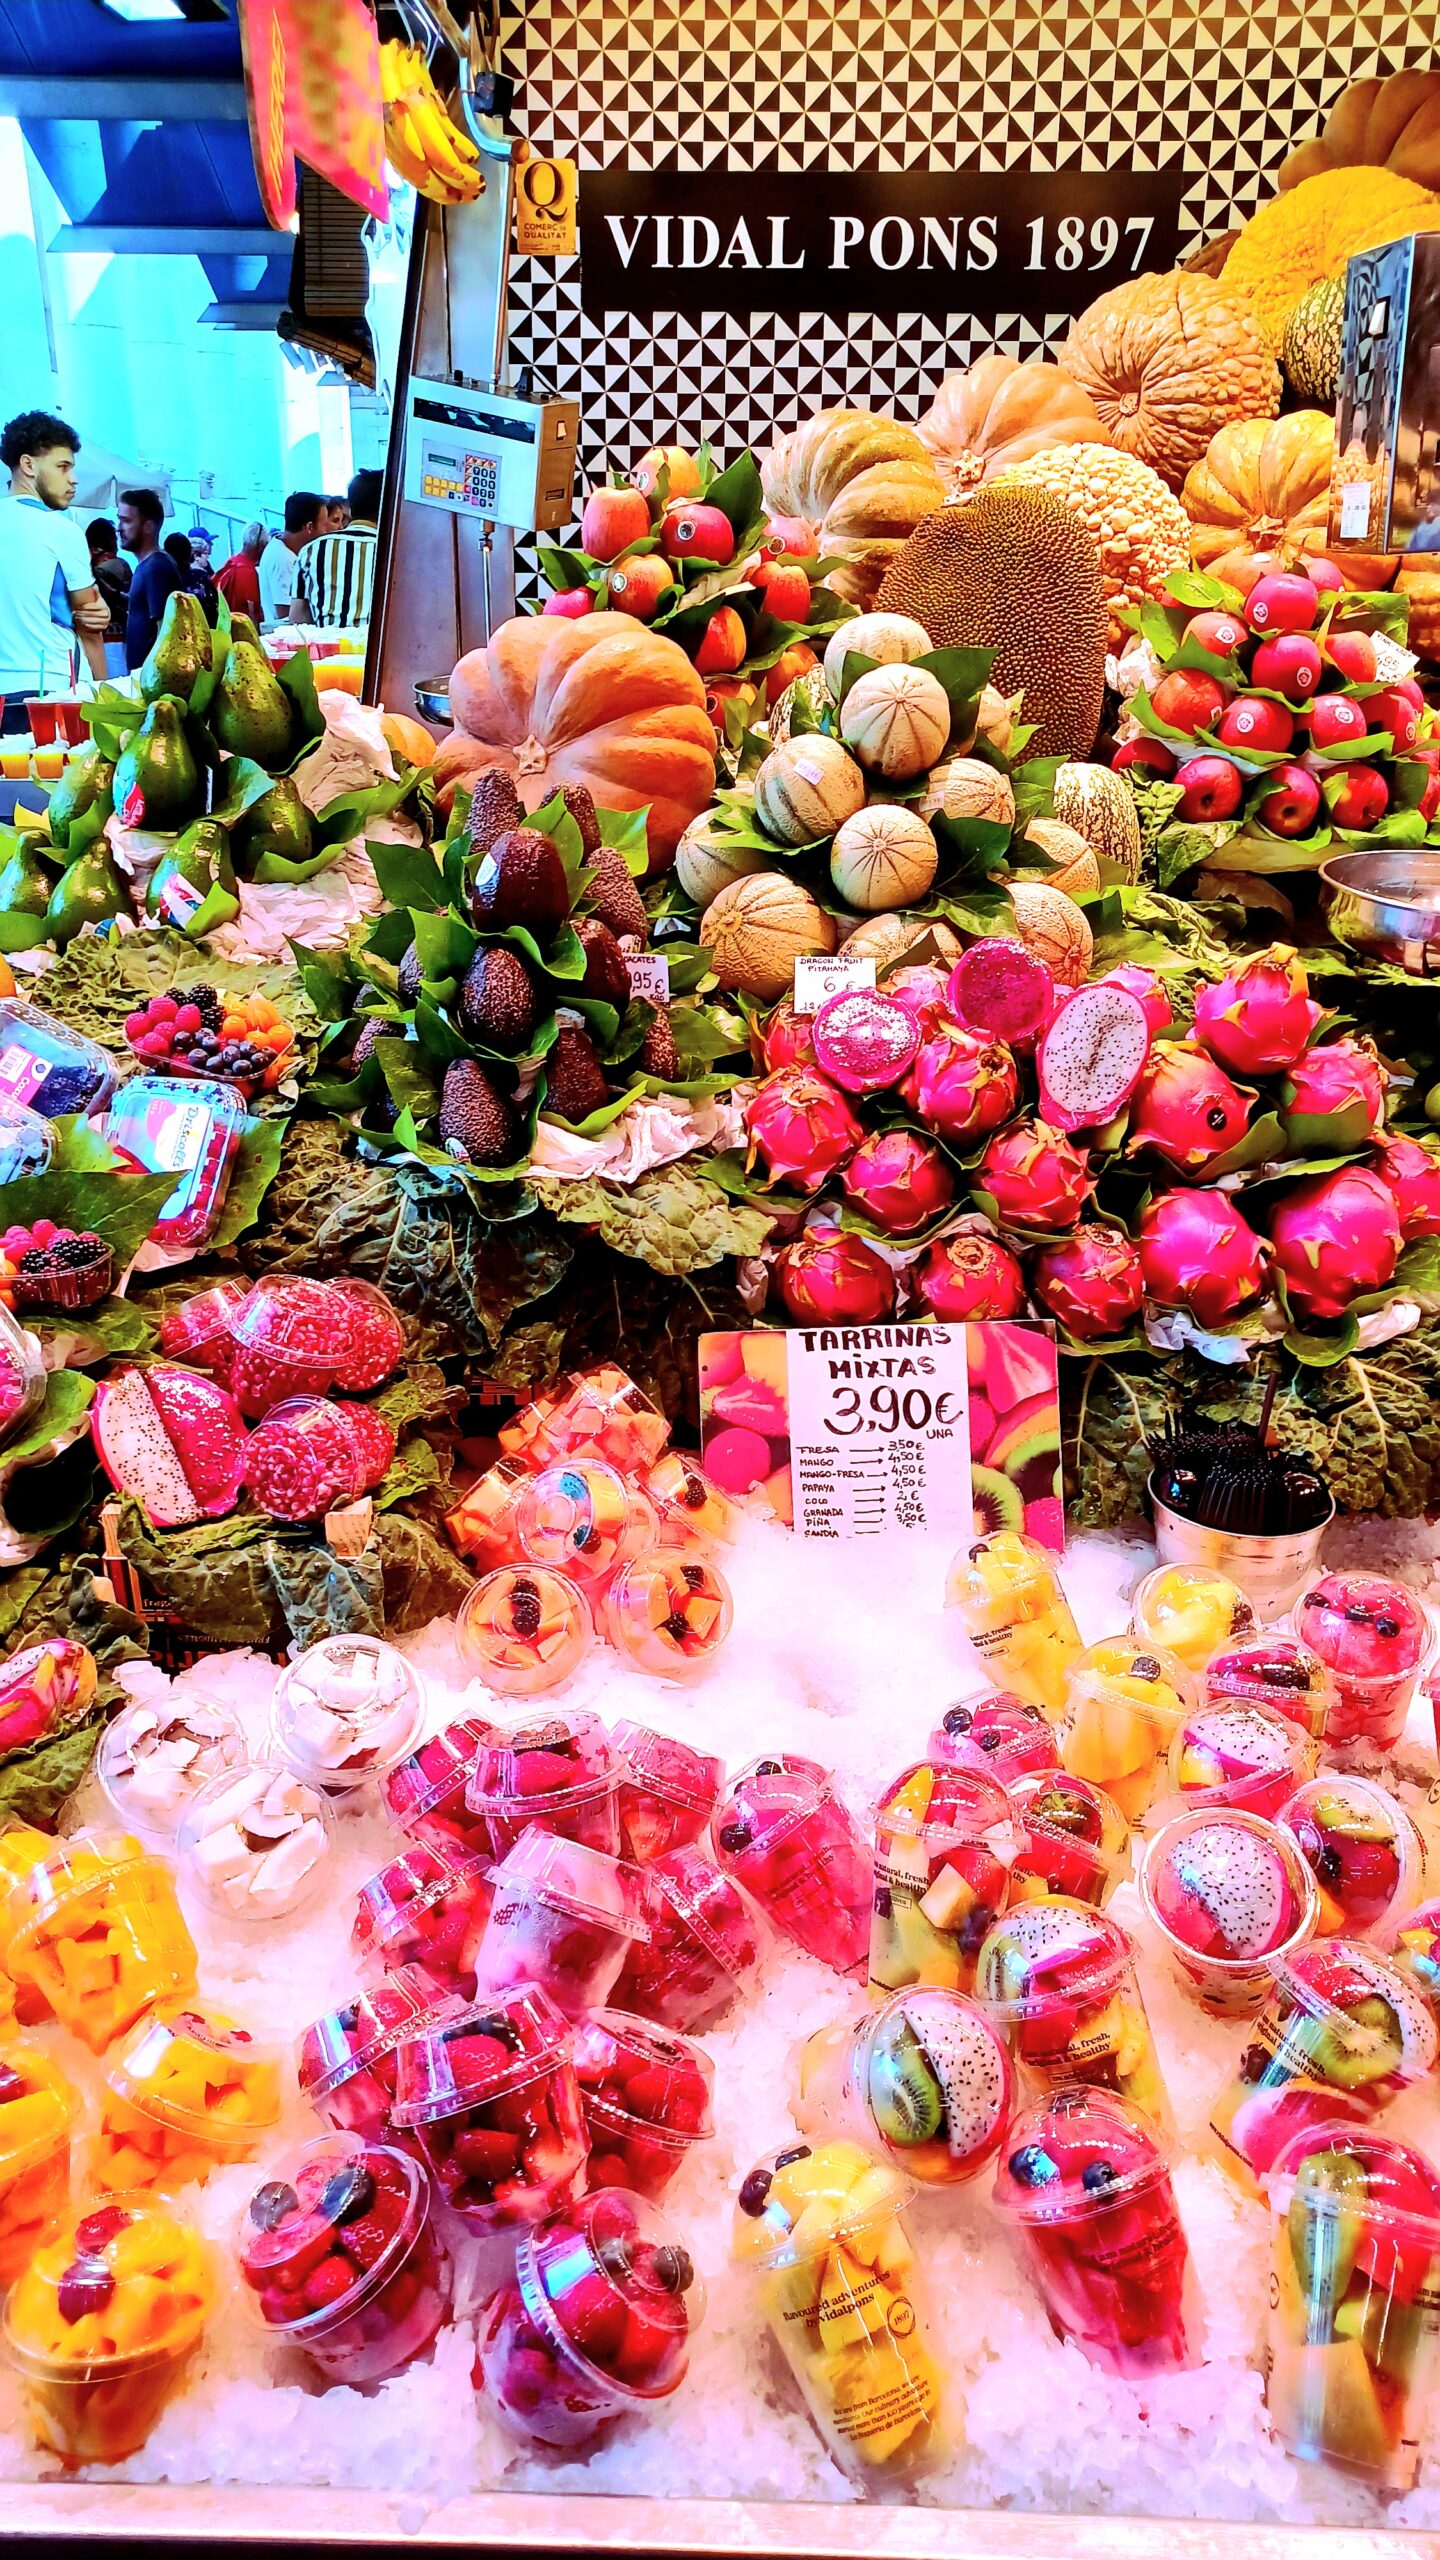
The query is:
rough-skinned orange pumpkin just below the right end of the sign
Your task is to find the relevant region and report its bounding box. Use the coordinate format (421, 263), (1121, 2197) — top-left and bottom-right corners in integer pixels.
(1061, 269), (1281, 489)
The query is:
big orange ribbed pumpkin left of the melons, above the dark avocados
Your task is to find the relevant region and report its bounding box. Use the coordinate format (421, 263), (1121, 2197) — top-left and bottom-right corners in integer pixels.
(433, 614), (715, 870)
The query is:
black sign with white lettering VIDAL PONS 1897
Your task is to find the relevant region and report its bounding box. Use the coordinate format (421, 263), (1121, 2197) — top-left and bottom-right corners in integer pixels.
(579, 169), (1186, 317)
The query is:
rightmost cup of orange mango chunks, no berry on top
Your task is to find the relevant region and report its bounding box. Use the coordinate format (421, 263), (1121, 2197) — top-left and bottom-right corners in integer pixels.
(90, 1999), (279, 2191)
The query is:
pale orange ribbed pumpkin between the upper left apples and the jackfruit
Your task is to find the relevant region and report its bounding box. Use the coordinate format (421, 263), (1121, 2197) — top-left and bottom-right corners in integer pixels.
(764, 410), (945, 612)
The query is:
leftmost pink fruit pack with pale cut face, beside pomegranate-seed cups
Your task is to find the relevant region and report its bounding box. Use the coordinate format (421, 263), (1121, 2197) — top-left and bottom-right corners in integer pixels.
(90, 1362), (249, 1528)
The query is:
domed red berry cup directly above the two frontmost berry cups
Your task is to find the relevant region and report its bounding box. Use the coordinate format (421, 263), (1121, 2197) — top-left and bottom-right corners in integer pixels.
(395, 1981), (587, 2237)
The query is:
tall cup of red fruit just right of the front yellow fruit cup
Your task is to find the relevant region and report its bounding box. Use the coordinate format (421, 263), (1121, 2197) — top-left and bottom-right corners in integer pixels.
(994, 2089), (1199, 2381)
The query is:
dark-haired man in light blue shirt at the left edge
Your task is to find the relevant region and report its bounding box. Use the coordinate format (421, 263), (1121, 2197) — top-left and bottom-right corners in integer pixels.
(0, 410), (110, 730)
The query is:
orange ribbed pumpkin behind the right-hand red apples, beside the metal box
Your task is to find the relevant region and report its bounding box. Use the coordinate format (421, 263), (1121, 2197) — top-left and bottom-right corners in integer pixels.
(1181, 410), (1396, 589)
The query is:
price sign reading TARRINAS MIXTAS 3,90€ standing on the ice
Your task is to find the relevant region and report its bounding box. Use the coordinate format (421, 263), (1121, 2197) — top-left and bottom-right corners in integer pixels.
(700, 1324), (1063, 1554)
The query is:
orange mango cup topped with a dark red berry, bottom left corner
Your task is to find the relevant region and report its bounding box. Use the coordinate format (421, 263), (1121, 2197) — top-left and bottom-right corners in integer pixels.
(3, 2194), (215, 2470)
